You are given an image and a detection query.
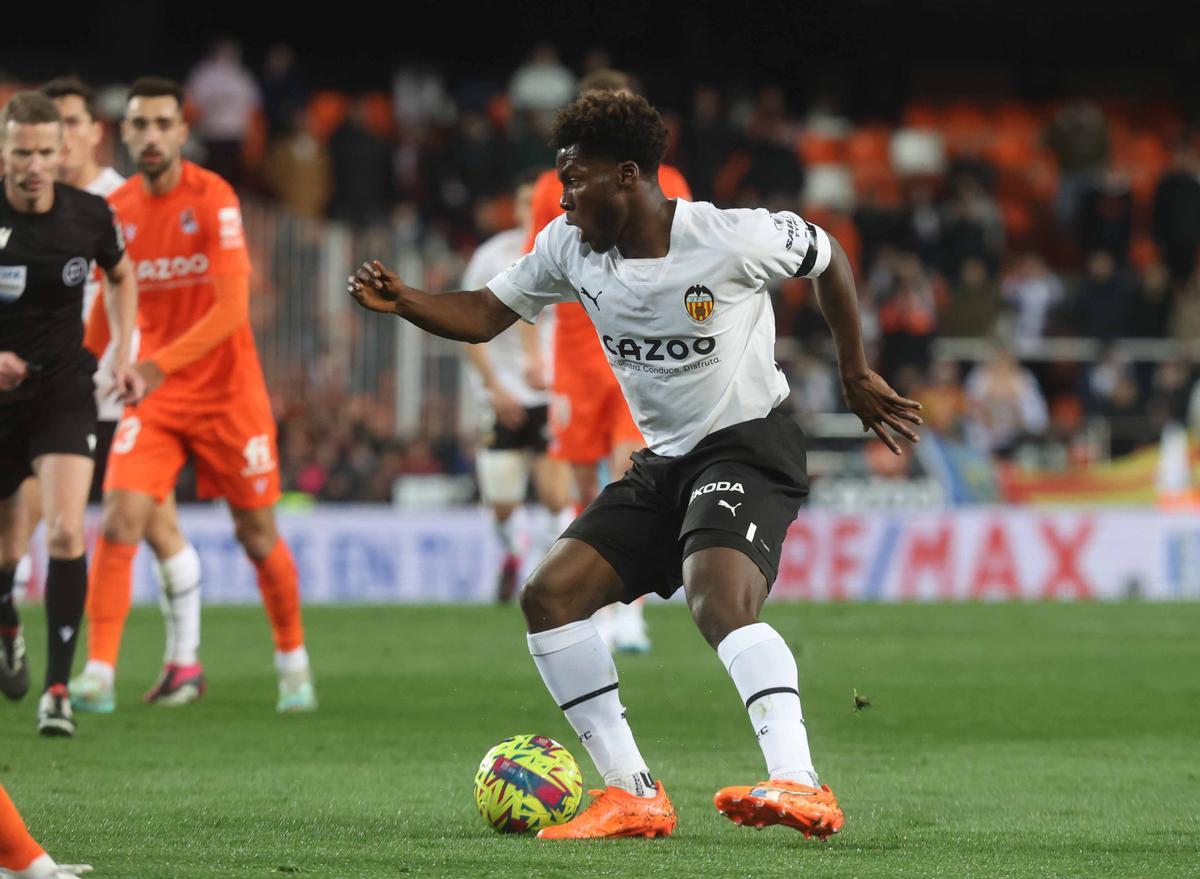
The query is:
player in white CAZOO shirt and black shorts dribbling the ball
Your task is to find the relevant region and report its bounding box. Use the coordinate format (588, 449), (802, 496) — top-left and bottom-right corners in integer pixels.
(349, 92), (920, 839)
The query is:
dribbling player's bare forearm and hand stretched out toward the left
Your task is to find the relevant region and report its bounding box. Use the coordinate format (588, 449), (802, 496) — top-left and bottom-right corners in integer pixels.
(347, 259), (517, 342)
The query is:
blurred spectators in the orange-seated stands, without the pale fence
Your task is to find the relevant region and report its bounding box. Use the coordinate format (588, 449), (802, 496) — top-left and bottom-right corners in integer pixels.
(4, 42), (1200, 501)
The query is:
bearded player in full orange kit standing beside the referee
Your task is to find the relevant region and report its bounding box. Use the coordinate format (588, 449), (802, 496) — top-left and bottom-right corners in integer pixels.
(71, 77), (317, 711)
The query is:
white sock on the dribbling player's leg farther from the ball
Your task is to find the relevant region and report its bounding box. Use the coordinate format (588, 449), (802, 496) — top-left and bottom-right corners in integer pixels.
(716, 623), (817, 787)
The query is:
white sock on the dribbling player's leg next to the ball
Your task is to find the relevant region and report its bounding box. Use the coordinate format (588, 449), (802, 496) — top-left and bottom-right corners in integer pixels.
(527, 620), (658, 797)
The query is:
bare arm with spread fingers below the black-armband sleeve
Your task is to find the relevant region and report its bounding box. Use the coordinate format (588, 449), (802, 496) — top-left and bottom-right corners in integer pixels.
(812, 235), (922, 455)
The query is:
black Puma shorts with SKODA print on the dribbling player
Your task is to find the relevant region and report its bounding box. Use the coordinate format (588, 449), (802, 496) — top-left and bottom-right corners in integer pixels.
(563, 408), (809, 602)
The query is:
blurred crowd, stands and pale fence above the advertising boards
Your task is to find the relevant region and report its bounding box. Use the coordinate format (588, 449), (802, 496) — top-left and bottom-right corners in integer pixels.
(0, 6), (1200, 502)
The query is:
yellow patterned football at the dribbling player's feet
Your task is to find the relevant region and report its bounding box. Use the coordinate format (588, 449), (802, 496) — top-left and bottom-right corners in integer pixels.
(475, 735), (583, 833)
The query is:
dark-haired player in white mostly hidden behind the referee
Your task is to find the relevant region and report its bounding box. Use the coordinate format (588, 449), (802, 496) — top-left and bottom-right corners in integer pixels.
(4, 77), (204, 705)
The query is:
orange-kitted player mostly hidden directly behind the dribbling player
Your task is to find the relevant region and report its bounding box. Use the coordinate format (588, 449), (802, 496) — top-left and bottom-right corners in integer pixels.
(525, 70), (691, 653)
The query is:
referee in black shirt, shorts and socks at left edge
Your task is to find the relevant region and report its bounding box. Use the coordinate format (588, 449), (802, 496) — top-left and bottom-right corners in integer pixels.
(0, 91), (144, 736)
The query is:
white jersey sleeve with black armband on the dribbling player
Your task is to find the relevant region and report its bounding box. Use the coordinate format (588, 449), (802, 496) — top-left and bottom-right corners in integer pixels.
(726, 208), (833, 281)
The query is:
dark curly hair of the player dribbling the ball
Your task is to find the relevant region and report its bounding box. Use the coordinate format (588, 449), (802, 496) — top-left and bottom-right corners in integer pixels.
(550, 91), (667, 173)
